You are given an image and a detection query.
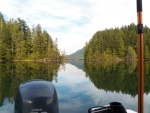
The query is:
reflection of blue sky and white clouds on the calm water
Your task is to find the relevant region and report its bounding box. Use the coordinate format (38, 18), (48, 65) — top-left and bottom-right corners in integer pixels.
(54, 64), (137, 113)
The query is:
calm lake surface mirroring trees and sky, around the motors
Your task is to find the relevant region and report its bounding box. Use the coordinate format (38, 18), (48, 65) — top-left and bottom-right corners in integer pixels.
(0, 61), (150, 113)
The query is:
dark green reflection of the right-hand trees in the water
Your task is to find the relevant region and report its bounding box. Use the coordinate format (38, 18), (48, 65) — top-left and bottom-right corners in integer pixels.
(85, 61), (150, 97)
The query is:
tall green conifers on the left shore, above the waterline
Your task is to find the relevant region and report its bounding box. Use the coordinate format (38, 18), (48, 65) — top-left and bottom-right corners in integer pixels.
(0, 13), (63, 60)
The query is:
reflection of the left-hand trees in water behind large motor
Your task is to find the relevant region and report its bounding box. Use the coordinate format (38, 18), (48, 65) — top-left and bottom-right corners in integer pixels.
(0, 62), (60, 106)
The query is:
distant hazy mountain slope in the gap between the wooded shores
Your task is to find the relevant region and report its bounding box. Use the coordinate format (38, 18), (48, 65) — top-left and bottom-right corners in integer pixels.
(66, 47), (84, 59)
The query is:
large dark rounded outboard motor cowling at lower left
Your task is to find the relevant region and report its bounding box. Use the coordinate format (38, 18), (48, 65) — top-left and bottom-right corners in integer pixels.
(15, 80), (59, 113)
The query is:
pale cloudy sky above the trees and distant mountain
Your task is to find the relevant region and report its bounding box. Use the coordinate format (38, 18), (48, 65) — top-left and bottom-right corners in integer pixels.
(0, 0), (150, 55)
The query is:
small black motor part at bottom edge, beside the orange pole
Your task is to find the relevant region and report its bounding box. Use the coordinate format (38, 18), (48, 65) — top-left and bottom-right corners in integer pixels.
(88, 102), (127, 113)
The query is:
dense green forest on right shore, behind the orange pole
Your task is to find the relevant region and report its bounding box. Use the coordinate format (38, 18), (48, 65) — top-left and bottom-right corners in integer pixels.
(84, 23), (150, 59)
